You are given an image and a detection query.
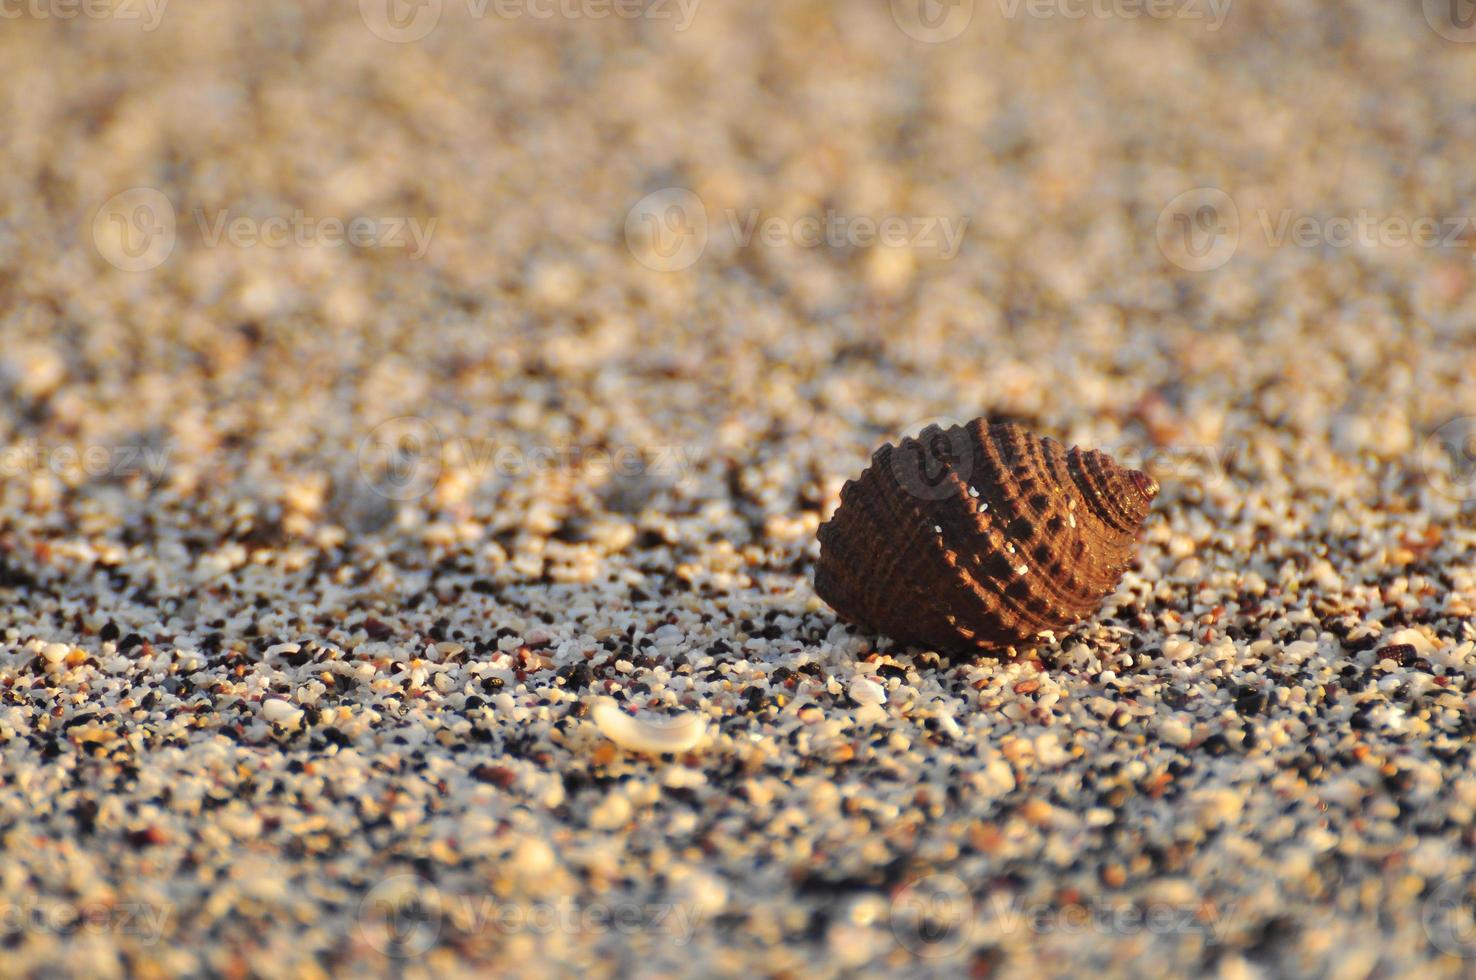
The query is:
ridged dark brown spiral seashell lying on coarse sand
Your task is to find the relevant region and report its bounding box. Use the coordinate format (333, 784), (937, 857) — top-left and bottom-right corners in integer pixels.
(815, 419), (1159, 654)
